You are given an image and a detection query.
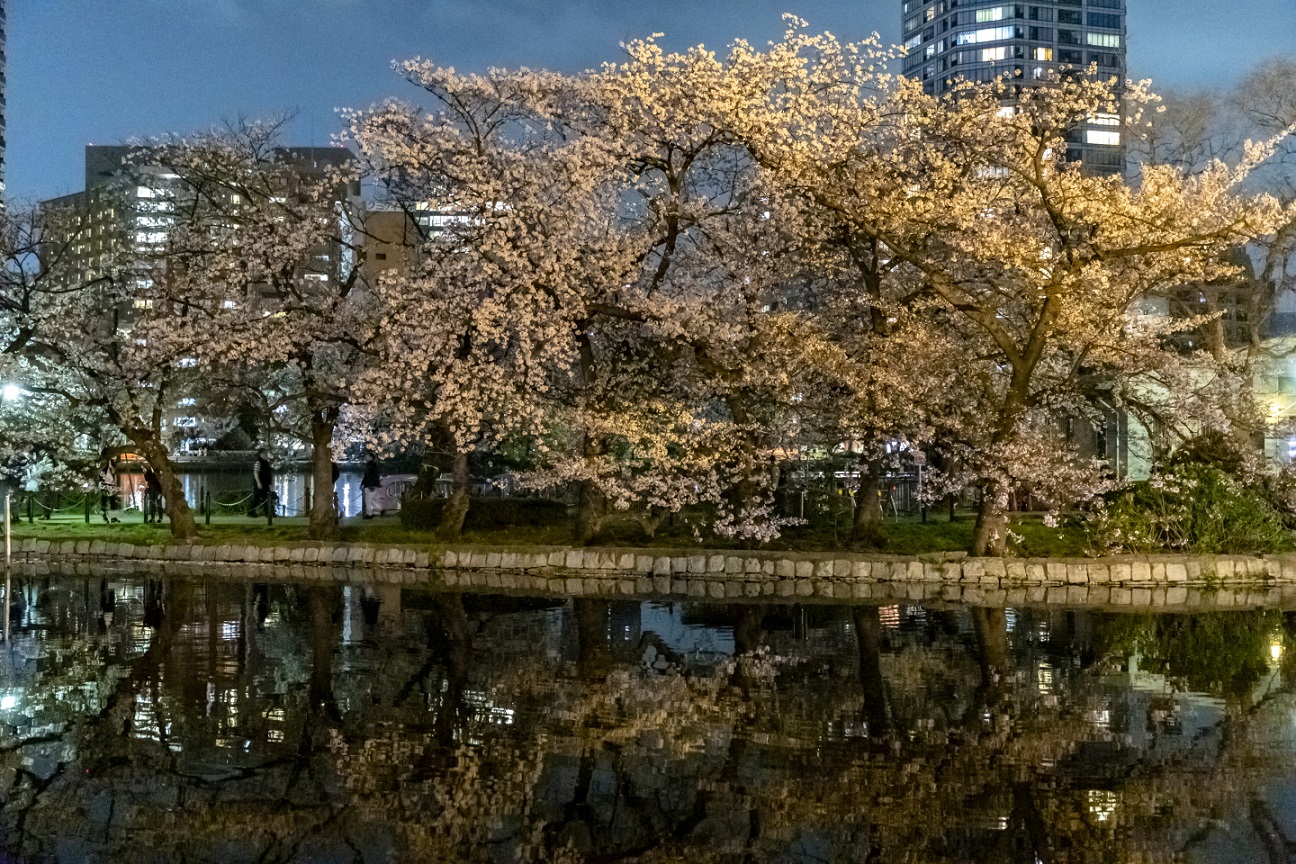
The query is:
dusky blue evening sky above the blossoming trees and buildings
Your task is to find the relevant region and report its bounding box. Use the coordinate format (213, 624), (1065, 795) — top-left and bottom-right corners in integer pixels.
(6, 0), (1296, 199)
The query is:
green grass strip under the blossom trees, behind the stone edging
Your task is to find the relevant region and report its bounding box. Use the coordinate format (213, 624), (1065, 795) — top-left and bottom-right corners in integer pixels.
(5, 512), (1087, 557)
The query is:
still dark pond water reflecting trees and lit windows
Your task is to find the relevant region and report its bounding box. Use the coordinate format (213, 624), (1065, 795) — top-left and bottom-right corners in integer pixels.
(0, 576), (1296, 864)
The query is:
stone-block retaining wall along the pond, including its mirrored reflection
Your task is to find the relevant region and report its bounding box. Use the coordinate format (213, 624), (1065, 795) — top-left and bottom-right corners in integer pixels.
(14, 540), (1296, 609)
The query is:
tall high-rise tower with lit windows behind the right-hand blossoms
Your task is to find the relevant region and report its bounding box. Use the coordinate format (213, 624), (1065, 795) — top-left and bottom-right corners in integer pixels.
(902, 0), (1125, 174)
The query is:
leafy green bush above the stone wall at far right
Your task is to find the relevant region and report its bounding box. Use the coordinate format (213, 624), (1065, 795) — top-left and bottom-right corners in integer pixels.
(1093, 462), (1293, 554)
